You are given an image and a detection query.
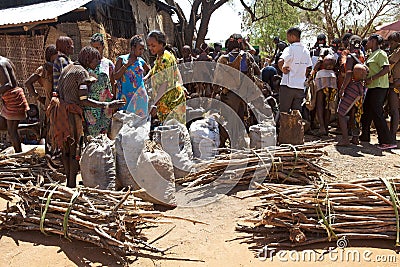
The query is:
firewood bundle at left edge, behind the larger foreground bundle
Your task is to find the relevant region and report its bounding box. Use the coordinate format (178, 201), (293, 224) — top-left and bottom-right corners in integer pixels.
(0, 148), (65, 188)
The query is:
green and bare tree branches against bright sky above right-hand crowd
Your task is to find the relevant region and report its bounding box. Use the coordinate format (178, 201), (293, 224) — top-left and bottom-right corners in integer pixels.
(243, 0), (400, 56)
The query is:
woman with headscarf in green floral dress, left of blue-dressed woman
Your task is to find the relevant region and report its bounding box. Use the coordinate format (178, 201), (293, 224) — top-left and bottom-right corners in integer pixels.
(84, 33), (115, 137)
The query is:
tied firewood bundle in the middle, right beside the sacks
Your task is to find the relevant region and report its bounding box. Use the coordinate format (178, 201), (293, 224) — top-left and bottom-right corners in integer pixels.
(175, 142), (333, 187)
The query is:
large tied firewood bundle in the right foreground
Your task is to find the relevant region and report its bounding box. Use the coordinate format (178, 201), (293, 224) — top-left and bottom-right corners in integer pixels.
(236, 178), (400, 249)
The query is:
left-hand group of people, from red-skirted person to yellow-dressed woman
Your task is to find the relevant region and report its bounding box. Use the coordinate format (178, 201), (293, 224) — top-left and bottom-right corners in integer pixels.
(0, 31), (186, 187)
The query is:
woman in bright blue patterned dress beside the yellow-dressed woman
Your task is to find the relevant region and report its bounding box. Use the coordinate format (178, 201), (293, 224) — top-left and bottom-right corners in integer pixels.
(114, 35), (150, 118)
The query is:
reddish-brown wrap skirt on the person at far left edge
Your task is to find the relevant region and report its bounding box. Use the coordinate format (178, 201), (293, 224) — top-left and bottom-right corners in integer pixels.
(0, 87), (29, 121)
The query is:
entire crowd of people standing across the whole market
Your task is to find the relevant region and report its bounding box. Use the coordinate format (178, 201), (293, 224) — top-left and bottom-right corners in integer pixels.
(0, 27), (400, 187)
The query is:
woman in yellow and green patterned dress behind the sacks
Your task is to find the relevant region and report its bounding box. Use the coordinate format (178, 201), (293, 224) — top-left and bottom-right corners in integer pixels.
(147, 31), (186, 124)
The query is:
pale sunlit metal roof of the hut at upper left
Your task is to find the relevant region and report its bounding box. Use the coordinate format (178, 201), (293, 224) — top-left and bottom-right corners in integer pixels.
(0, 0), (92, 27)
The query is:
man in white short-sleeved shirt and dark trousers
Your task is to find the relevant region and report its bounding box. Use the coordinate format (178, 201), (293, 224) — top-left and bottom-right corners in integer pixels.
(278, 27), (312, 112)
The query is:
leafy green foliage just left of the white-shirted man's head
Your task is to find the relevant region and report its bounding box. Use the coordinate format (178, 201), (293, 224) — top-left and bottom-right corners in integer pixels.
(243, 0), (301, 56)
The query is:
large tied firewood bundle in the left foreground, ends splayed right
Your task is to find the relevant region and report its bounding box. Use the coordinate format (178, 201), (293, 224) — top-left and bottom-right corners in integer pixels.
(0, 184), (202, 262)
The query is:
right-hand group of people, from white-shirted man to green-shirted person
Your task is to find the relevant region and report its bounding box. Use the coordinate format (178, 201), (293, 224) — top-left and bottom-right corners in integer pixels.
(278, 28), (400, 150)
